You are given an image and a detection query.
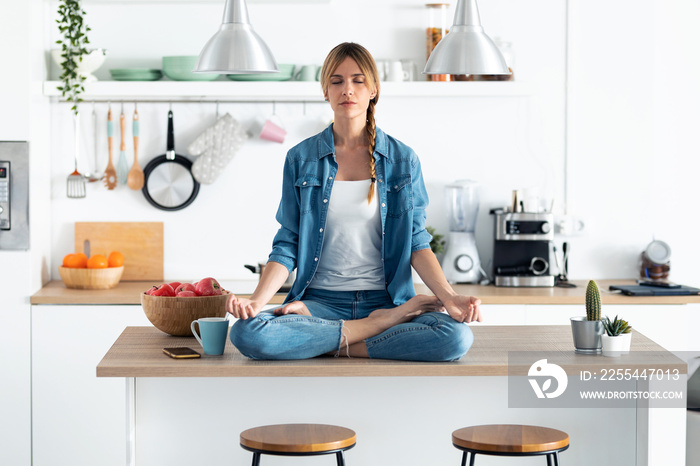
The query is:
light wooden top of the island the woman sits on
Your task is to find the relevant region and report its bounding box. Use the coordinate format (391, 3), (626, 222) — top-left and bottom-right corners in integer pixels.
(97, 325), (687, 377)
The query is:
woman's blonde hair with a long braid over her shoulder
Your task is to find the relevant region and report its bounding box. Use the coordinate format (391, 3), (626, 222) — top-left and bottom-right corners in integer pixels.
(320, 42), (379, 203)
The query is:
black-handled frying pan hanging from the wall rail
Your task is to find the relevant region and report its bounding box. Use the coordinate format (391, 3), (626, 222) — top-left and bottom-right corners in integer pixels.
(141, 110), (199, 211)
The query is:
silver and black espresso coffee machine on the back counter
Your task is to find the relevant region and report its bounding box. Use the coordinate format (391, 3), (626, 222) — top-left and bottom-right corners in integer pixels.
(491, 209), (555, 287)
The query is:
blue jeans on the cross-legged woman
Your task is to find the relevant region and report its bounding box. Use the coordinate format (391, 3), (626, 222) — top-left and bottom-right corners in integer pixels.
(230, 289), (474, 361)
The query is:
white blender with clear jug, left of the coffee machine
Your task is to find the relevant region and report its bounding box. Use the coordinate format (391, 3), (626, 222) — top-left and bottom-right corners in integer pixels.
(440, 180), (481, 283)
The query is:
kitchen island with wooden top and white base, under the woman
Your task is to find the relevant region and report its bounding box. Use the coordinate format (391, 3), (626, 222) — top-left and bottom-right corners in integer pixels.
(97, 326), (687, 466)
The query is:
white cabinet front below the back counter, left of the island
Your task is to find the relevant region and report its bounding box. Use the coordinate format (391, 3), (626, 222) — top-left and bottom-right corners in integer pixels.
(31, 305), (150, 466)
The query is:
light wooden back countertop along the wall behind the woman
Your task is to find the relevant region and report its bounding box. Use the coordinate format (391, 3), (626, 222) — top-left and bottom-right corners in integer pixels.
(30, 280), (700, 305)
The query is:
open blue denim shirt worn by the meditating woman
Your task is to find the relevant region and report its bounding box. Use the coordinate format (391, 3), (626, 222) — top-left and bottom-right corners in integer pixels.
(269, 125), (432, 305)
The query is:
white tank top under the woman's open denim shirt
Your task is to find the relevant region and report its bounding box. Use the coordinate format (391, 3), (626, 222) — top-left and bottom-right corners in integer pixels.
(309, 180), (385, 291)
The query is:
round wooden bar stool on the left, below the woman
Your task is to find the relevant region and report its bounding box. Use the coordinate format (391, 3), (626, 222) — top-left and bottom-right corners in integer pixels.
(241, 424), (357, 466)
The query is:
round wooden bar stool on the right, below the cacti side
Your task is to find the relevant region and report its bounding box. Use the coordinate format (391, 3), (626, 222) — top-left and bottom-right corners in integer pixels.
(452, 424), (569, 466)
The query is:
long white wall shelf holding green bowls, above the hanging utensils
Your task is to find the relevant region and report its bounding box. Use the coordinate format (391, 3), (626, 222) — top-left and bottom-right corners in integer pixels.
(43, 81), (534, 102)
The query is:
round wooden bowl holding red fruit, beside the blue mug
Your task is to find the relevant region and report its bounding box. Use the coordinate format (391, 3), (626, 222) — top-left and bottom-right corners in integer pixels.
(141, 291), (231, 337)
